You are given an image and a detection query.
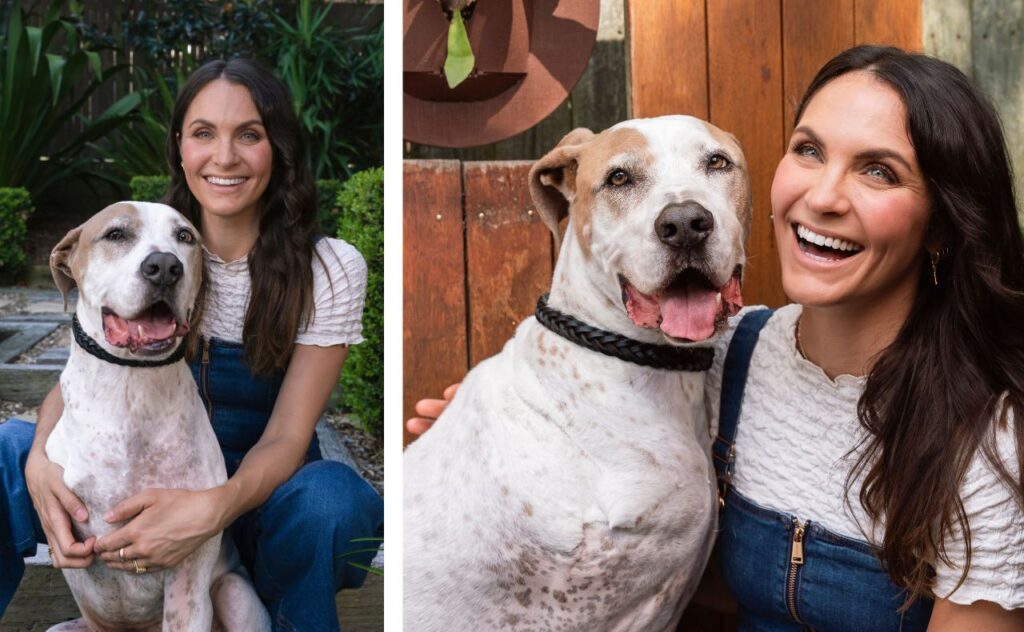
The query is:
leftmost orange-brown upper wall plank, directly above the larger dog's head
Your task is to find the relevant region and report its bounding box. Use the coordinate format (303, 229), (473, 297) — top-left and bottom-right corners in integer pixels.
(629, 0), (708, 119)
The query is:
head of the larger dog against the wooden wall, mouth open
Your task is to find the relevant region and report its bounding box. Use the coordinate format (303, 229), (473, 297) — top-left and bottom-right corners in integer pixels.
(529, 116), (751, 343)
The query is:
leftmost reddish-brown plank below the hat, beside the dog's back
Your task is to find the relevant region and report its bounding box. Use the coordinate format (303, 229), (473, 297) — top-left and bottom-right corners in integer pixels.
(402, 161), (469, 444)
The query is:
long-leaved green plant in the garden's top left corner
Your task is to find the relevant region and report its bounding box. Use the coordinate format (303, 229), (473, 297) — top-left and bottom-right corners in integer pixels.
(0, 0), (140, 196)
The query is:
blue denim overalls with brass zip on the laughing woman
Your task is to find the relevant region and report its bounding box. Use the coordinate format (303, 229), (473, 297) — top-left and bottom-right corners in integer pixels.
(714, 309), (932, 632)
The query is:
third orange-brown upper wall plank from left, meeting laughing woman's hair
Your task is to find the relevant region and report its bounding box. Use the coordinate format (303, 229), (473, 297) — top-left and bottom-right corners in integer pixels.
(782, 0), (854, 137)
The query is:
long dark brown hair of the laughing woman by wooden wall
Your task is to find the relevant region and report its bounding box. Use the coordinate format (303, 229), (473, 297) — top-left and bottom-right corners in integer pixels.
(797, 46), (1024, 604)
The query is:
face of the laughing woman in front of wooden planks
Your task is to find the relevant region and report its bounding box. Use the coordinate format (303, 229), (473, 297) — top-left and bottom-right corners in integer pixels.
(771, 71), (931, 307)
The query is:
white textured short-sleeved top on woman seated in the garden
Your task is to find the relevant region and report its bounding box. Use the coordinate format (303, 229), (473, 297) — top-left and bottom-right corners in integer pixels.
(200, 239), (367, 346)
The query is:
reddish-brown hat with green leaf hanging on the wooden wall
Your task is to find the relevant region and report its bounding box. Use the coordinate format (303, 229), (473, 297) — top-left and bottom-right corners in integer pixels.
(402, 0), (600, 148)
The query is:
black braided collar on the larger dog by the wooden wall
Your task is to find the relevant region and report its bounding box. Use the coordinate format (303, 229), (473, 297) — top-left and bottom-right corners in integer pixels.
(535, 294), (715, 372)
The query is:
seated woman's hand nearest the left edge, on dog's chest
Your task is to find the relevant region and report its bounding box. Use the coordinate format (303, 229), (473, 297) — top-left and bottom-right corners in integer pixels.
(25, 450), (96, 568)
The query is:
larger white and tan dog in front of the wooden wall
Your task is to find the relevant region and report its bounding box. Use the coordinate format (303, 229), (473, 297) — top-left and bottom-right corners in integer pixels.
(403, 116), (751, 632)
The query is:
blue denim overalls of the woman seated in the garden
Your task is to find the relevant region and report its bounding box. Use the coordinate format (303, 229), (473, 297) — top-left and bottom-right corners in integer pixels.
(0, 340), (384, 631)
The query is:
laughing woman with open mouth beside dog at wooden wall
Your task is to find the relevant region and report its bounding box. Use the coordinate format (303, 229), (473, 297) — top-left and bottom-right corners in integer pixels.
(410, 46), (1024, 630)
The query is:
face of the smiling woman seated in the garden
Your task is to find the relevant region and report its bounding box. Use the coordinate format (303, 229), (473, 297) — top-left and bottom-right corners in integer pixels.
(180, 79), (273, 226)
